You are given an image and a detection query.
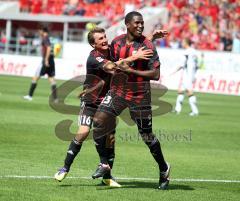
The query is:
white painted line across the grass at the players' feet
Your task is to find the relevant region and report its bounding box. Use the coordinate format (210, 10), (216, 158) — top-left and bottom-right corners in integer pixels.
(0, 175), (240, 183)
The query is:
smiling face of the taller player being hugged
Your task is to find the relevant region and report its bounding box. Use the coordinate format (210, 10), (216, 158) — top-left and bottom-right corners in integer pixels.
(127, 16), (144, 38)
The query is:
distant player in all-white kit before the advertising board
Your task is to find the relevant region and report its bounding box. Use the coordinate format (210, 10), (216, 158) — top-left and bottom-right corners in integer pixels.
(175, 39), (199, 116)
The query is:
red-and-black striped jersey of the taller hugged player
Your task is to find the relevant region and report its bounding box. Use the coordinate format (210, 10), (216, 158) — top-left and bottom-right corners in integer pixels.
(110, 34), (160, 102)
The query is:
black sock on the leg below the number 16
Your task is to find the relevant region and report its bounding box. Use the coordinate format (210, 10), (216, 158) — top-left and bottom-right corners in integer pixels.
(64, 139), (82, 171)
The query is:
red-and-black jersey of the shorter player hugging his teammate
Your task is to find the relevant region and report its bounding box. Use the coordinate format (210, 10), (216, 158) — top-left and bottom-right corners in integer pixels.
(82, 50), (111, 104)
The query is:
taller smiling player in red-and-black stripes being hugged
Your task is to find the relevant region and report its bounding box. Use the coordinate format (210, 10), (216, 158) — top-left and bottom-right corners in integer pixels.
(92, 11), (170, 189)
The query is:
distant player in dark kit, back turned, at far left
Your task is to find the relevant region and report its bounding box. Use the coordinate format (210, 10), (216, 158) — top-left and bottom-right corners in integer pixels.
(23, 27), (58, 102)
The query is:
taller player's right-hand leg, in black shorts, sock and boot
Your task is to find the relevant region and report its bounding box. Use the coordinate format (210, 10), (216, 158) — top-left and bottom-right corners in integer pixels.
(130, 106), (170, 189)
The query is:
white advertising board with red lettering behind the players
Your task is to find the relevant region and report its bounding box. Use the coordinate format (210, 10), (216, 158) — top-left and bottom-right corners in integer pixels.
(0, 46), (240, 96)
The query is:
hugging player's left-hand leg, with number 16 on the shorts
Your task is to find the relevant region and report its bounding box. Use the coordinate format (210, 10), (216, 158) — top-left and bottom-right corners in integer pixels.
(55, 102), (96, 181)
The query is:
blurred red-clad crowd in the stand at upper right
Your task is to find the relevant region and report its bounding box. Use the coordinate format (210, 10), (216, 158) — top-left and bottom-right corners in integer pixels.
(156, 0), (240, 53)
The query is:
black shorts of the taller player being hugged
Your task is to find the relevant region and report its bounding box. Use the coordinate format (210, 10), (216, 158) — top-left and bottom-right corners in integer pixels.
(98, 91), (152, 133)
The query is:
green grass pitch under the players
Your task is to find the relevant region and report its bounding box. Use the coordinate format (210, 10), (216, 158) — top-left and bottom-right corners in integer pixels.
(0, 75), (240, 201)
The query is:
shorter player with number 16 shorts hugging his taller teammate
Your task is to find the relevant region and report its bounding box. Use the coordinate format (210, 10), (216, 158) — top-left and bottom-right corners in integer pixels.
(55, 27), (159, 187)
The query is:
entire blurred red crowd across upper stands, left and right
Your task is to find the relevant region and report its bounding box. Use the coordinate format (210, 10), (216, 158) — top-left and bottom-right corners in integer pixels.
(12, 0), (240, 53)
